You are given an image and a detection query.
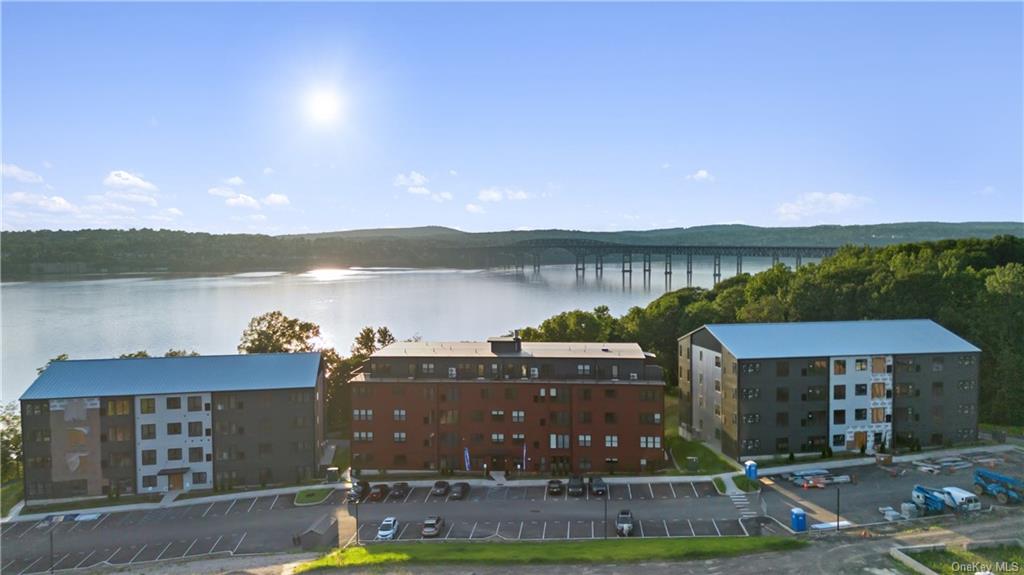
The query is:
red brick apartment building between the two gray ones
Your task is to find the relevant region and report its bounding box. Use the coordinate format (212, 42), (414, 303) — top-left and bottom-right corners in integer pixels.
(350, 336), (666, 473)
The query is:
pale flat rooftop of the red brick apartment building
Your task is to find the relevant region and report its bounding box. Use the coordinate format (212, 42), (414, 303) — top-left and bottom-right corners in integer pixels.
(373, 340), (648, 359)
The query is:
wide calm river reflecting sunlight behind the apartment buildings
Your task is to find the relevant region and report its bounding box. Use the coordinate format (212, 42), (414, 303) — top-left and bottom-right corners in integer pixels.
(0, 258), (770, 402)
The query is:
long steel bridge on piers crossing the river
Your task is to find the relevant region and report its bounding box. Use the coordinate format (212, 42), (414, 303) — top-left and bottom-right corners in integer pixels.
(482, 238), (838, 286)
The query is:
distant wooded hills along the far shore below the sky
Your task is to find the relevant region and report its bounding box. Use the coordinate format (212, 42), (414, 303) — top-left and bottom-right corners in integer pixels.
(0, 222), (1024, 281)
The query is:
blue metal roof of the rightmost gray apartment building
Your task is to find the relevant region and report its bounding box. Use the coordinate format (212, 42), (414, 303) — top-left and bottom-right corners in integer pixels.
(705, 319), (981, 359)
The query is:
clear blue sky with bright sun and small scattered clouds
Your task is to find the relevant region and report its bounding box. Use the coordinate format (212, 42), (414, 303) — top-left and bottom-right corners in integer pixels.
(2, 2), (1024, 233)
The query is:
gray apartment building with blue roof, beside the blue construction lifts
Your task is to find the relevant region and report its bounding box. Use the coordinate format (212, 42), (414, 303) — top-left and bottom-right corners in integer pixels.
(679, 319), (981, 459)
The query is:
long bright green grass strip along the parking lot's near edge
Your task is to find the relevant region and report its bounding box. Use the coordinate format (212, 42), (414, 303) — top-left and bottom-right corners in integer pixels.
(295, 537), (806, 573)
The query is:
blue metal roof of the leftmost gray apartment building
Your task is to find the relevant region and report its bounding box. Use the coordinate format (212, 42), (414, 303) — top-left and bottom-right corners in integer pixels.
(22, 352), (321, 400)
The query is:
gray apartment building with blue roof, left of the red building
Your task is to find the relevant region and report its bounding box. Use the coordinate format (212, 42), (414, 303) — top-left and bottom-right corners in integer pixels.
(20, 353), (324, 501)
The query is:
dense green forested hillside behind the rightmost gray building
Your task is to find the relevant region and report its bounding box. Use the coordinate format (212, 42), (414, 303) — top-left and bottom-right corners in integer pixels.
(522, 236), (1024, 426)
